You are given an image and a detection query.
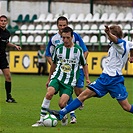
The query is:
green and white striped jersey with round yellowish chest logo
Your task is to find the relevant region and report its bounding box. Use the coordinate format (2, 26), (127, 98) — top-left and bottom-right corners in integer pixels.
(51, 44), (86, 86)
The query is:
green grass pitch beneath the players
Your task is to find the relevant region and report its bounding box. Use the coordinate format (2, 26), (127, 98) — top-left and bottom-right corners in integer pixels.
(0, 74), (133, 133)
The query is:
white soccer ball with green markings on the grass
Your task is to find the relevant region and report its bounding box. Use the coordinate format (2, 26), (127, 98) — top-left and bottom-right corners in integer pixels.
(43, 114), (58, 127)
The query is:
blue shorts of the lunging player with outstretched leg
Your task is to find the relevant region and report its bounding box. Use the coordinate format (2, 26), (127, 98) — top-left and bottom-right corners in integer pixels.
(88, 73), (128, 101)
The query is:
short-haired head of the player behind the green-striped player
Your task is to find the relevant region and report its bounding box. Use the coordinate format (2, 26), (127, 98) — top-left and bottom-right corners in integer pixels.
(57, 16), (68, 34)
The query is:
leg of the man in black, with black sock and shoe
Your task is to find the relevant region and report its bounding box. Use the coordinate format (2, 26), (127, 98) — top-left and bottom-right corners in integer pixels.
(2, 68), (16, 103)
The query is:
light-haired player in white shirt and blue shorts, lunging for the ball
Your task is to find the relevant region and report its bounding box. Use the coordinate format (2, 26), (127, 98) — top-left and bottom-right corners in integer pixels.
(47, 25), (133, 120)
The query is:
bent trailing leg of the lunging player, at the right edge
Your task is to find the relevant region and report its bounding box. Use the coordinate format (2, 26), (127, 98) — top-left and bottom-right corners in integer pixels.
(118, 98), (133, 113)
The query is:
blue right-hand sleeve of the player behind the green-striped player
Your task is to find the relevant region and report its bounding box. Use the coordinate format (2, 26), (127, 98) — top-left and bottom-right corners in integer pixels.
(73, 32), (88, 52)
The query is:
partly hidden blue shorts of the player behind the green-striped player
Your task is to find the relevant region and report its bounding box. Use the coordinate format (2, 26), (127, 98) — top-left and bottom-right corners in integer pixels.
(76, 69), (84, 88)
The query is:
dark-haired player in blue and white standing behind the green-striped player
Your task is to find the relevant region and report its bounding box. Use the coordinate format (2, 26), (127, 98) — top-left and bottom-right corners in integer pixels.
(46, 16), (88, 123)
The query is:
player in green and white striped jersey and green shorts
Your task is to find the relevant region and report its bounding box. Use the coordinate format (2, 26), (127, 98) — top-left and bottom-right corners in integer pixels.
(32, 27), (90, 127)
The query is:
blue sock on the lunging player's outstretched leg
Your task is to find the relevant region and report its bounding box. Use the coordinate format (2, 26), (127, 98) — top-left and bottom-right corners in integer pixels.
(59, 98), (82, 116)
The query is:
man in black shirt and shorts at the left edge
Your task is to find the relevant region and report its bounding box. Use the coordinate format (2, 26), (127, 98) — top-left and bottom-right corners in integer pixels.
(0, 15), (21, 103)
